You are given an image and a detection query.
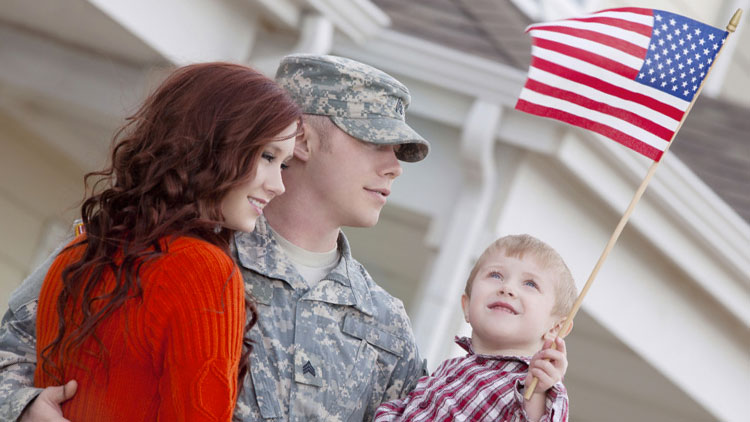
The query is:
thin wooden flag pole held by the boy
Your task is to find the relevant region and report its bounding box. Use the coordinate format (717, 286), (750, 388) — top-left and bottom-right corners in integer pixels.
(523, 9), (742, 400)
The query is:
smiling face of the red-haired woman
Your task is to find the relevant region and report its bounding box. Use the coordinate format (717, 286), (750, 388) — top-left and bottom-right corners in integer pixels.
(221, 122), (297, 232)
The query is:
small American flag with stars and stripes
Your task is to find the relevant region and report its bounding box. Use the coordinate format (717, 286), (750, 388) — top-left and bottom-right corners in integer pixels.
(516, 7), (728, 161)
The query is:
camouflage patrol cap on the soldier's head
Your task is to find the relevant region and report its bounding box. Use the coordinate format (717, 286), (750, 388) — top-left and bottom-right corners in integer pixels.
(276, 54), (430, 162)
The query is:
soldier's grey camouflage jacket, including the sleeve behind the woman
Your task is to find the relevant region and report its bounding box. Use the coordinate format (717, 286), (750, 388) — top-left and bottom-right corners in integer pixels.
(0, 218), (425, 421)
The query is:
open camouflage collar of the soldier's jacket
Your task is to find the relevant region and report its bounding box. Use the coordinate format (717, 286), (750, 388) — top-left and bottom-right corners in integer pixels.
(234, 217), (375, 315)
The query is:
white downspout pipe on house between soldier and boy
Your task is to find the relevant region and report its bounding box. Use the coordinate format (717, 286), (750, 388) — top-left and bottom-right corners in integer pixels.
(413, 99), (501, 365)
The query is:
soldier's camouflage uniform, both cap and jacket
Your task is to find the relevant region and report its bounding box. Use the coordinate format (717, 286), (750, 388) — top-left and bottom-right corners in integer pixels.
(0, 55), (429, 421)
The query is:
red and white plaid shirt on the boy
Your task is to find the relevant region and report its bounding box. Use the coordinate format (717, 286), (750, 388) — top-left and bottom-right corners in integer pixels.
(374, 337), (568, 422)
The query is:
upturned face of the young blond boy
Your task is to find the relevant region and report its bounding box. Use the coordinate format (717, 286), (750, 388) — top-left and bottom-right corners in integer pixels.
(461, 251), (563, 356)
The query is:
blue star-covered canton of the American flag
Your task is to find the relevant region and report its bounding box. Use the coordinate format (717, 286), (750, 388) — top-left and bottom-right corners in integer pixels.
(637, 9), (728, 102)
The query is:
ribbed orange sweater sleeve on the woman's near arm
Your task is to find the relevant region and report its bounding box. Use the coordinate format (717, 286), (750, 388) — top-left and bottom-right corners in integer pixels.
(144, 240), (245, 421)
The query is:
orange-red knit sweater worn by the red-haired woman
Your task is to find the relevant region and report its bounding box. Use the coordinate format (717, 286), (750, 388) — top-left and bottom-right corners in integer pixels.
(34, 237), (245, 422)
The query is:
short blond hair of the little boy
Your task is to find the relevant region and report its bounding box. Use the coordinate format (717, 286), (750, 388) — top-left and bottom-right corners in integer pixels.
(464, 234), (578, 316)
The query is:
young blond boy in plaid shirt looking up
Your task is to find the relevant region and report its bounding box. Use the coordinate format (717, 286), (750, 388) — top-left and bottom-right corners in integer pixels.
(375, 235), (576, 422)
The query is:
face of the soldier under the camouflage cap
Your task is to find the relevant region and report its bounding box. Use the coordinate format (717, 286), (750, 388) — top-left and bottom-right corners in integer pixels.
(309, 126), (402, 227)
